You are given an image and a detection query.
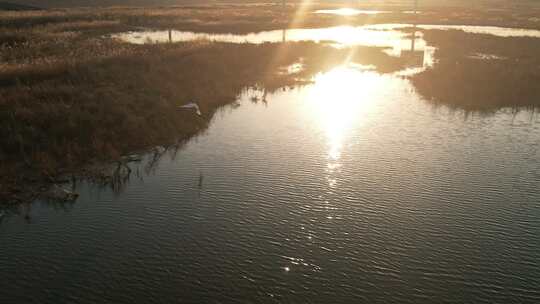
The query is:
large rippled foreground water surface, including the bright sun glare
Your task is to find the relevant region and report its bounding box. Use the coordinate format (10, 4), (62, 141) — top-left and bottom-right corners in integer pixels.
(0, 65), (540, 303)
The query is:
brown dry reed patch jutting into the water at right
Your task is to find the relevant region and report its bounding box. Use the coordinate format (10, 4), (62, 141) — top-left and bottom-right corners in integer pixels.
(412, 31), (540, 111)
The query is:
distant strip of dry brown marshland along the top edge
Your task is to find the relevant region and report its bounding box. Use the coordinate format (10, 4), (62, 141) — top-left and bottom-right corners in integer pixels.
(0, 1), (540, 33)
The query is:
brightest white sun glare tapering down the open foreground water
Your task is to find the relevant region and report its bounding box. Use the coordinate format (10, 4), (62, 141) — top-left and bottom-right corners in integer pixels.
(302, 62), (407, 230)
